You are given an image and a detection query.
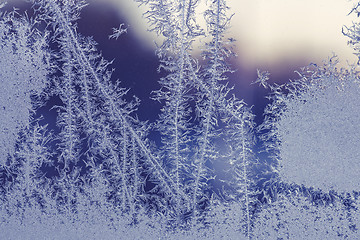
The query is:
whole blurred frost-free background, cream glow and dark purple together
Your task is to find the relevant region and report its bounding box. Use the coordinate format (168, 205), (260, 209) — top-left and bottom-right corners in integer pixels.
(8, 0), (357, 123)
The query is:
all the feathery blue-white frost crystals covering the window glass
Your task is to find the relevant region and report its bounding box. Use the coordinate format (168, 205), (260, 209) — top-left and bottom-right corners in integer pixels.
(0, 0), (360, 239)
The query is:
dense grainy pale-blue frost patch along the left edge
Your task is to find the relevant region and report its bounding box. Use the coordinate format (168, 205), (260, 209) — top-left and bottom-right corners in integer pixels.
(0, 13), (49, 164)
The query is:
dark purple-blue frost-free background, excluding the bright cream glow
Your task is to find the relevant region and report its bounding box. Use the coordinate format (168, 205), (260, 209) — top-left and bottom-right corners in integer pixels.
(9, 0), (358, 123)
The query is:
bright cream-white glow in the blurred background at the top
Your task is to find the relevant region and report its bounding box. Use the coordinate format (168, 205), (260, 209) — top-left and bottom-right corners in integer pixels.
(99, 0), (357, 68)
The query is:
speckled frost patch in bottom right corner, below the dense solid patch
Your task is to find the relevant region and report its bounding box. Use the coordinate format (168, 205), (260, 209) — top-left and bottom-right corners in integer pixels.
(254, 192), (359, 240)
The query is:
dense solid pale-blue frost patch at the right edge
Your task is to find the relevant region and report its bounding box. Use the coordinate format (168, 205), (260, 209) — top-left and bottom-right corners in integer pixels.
(272, 59), (360, 192)
